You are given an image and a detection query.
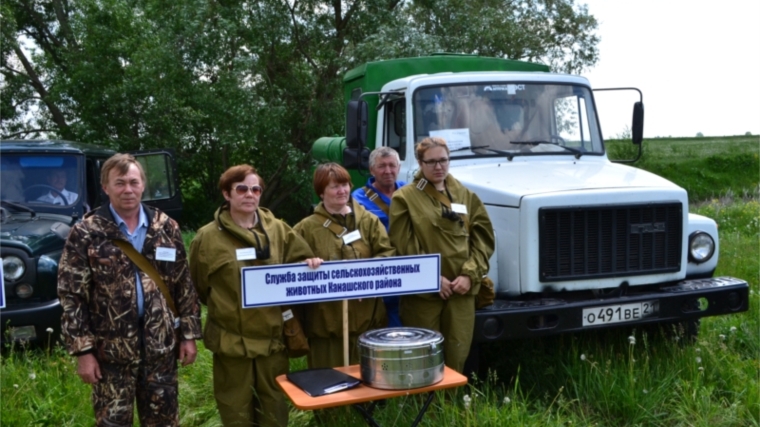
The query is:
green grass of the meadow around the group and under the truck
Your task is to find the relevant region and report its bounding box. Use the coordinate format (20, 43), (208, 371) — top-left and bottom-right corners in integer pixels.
(0, 137), (760, 427)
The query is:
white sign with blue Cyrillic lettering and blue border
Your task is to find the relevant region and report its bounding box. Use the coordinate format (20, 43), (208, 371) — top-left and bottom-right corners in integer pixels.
(242, 254), (441, 308)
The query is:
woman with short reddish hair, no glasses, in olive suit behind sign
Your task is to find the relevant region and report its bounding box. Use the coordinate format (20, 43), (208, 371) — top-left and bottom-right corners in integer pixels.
(294, 163), (395, 368)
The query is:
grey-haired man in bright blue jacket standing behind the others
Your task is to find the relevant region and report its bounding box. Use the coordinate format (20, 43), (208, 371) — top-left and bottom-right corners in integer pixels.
(351, 147), (406, 327)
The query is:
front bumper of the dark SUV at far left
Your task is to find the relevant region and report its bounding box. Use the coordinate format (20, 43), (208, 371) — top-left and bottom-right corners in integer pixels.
(0, 298), (63, 344)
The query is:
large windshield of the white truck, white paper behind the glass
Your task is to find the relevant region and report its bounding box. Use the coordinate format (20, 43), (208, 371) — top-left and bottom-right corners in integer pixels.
(413, 83), (603, 157)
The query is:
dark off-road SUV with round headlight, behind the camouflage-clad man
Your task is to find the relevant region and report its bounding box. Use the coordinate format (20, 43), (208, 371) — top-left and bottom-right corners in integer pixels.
(0, 140), (182, 344)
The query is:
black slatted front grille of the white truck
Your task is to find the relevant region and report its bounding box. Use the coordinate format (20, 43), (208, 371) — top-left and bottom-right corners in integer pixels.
(538, 202), (683, 282)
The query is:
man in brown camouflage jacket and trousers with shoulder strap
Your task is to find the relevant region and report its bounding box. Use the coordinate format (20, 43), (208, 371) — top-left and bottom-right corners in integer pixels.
(58, 154), (201, 426)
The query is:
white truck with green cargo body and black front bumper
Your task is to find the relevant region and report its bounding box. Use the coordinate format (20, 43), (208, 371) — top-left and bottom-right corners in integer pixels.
(313, 56), (748, 342)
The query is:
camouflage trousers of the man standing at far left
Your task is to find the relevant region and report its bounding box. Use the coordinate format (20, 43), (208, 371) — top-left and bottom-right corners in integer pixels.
(92, 352), (179, 427)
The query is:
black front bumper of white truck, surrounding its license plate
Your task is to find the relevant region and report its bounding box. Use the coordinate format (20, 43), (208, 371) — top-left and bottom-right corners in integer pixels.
(473, 277), (749, 343)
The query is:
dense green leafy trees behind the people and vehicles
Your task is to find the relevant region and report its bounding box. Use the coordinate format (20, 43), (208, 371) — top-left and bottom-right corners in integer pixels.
(0, 0), (599, 226)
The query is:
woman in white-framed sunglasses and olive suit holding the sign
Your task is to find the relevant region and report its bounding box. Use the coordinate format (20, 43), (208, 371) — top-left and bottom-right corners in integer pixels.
(190, 165), (322, 427)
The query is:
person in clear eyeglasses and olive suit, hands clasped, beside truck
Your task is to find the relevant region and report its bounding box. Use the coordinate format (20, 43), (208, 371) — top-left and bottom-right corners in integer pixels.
(389, 137), (494, 373)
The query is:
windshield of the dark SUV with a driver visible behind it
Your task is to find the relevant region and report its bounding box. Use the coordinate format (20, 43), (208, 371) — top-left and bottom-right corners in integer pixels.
(0, 152), (83, 210)
